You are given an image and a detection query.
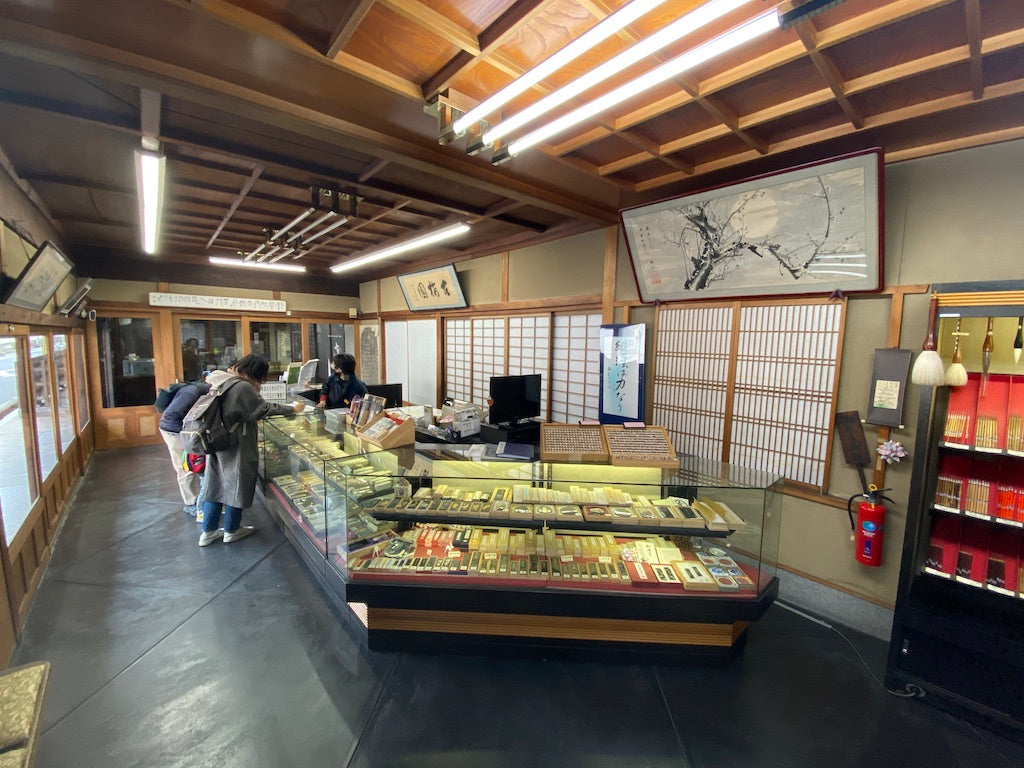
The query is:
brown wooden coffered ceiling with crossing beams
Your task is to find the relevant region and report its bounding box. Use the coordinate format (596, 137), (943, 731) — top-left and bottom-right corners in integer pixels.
(0, 0), (1024, 295)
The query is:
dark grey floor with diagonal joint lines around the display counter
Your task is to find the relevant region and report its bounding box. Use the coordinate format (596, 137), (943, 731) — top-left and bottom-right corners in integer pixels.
(12, 445), (1024, 768)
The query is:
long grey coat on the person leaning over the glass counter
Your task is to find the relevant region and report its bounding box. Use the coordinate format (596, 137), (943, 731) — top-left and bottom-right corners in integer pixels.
(206, 371), (295, 509)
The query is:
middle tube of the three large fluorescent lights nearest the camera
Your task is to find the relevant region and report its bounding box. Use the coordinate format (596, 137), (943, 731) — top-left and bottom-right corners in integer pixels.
(483, 0), (749, 145)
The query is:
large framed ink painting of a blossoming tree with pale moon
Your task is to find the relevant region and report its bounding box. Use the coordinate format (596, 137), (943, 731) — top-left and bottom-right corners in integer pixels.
(618, 150), (882, 302)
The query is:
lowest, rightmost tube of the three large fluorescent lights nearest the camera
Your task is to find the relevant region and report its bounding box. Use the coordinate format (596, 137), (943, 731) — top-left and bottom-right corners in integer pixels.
(495, 11), (778, 160)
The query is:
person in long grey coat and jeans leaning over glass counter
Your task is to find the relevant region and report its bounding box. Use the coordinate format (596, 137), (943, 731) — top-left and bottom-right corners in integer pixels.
(199, 354), (304, 547)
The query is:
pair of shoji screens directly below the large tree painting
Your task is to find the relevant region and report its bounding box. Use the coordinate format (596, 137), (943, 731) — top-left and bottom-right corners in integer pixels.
(652, 300), (846, 487)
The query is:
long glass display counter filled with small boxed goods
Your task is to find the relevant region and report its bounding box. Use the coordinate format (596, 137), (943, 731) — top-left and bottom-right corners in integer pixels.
(262, 413), (781, 658)
